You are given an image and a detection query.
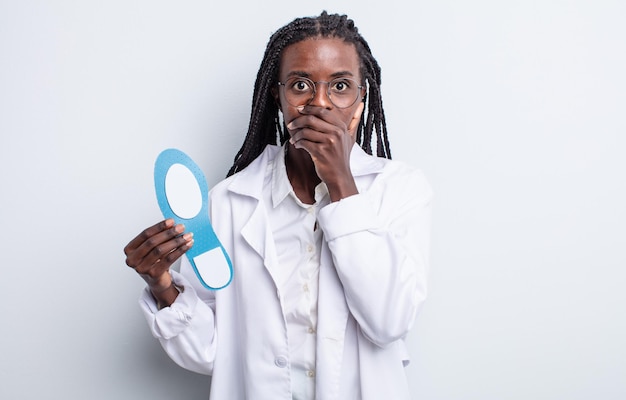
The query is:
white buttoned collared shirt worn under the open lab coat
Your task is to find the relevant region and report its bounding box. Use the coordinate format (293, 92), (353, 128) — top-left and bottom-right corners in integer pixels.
(263, 147), (329, 400)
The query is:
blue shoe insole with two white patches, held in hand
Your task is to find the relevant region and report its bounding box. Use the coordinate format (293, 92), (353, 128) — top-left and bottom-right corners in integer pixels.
(154, 149), (233, 290)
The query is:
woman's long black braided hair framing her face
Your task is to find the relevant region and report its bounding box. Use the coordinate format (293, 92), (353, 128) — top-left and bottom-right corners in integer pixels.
(228, 11), (391, 176)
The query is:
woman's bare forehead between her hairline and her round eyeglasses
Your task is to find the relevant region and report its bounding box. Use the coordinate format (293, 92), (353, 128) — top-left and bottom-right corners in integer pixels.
(279, 37), (360, 79)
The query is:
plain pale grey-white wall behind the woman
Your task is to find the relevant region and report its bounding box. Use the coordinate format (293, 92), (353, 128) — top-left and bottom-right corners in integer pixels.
(0, 0), (626, 400)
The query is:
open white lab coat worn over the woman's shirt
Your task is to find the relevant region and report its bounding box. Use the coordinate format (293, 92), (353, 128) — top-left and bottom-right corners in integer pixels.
(140, 146), (432, 400)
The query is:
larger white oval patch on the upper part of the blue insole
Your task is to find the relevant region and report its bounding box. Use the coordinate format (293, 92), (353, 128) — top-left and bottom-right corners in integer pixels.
(165, 164), (202, 219)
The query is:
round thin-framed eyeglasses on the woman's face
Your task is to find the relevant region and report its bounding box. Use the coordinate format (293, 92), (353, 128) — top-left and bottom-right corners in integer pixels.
(278, 76), (364, 108)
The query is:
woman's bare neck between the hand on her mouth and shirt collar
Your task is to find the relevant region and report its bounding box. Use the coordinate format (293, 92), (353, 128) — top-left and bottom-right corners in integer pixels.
(285, 143), (322, 204)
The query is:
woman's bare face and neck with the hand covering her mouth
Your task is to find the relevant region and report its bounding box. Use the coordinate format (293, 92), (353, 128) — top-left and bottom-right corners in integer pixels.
(274, 38), (365, 204)
